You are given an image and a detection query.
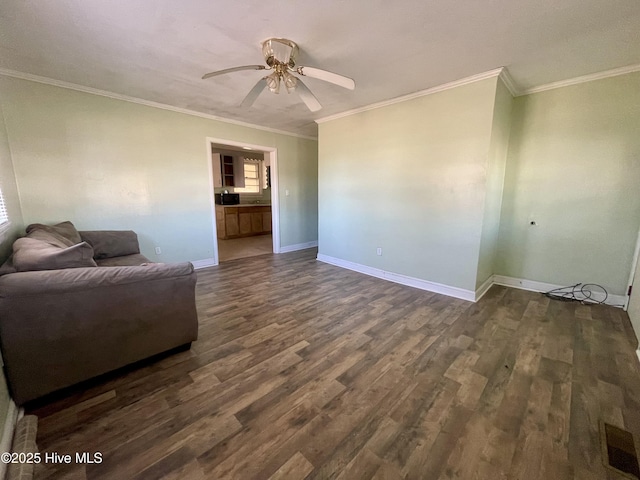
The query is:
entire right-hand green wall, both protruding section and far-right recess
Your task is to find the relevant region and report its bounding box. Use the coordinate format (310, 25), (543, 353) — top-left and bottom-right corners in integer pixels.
(319, 73), (640, 295)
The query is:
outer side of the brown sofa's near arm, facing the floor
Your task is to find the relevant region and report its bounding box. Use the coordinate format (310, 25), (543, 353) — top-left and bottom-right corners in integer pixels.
(0, 263), (198, 404)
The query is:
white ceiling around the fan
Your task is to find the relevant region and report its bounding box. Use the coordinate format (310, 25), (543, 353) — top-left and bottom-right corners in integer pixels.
(0, 0), (640, 136)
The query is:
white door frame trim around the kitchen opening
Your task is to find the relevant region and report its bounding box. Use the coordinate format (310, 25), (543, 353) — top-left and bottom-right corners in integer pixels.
(206, 137), (280, 265)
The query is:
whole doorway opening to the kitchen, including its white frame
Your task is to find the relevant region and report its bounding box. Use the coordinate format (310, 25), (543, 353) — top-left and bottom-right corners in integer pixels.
(206, 138), (280, 265)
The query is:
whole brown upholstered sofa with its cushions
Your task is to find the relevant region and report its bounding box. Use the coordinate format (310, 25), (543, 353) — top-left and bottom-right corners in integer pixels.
(0, 222), (198, 405)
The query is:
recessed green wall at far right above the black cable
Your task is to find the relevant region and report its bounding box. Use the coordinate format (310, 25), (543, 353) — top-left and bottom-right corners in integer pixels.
(495, 73), (640, 295)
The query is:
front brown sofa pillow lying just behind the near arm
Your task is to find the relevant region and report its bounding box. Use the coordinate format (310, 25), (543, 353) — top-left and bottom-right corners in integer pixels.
(13, 237), (97, 272)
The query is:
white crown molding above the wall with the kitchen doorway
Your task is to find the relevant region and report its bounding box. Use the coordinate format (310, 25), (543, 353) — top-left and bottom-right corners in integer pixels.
(0, 68), (318, 140)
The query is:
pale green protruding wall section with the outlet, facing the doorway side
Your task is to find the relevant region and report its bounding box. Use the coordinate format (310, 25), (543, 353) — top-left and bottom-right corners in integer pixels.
(318, 77), (497, 290)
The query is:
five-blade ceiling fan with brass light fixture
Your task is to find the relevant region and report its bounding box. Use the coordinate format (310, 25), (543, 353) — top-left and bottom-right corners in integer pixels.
(202, 38), (356, 112)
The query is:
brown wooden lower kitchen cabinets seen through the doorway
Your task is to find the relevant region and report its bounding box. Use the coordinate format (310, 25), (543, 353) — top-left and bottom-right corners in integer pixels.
(216, 205), (271, 240)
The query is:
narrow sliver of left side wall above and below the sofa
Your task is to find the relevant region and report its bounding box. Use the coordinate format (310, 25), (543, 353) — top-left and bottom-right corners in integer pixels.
(0, 94), (24, 446)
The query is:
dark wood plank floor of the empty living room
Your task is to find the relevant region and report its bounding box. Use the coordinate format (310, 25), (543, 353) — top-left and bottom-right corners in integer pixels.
(31, 250), (640, 480)
